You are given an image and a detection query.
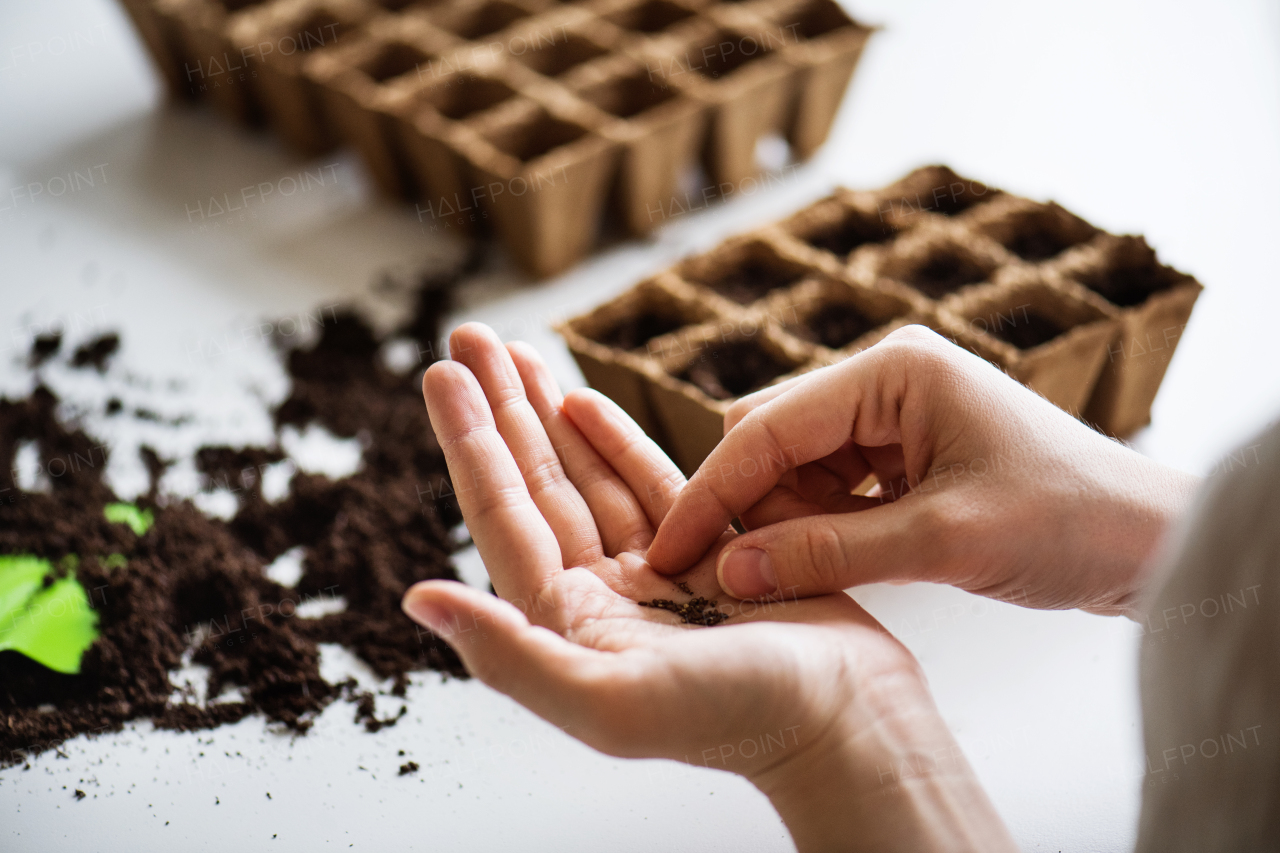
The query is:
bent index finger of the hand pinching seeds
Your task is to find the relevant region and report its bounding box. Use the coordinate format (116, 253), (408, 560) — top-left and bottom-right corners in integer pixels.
(648, 327), (942, 574)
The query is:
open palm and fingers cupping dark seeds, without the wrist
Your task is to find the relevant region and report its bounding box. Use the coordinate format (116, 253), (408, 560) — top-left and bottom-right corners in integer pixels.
(406, 324), (916, 775)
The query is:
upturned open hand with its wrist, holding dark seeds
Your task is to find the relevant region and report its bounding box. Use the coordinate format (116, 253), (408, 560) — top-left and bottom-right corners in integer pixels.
(404, 324), (1011, 850)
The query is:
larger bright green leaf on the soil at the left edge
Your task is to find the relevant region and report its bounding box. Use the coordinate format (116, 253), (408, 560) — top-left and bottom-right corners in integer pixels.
(0, 556), (97, 675)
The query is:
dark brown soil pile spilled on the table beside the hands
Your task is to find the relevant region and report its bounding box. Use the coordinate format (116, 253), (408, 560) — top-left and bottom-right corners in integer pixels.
(0, 261), (481, 767)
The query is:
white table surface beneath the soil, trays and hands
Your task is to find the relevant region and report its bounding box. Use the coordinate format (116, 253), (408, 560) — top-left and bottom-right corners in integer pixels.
(0, 0), (1280, 853)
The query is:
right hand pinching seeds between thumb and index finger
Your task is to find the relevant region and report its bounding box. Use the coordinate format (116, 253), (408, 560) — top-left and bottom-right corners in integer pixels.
(649, 327), (1196, 615)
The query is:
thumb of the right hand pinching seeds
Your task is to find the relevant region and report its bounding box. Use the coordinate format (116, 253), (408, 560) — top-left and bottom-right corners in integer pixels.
(716, 501), (938, 598)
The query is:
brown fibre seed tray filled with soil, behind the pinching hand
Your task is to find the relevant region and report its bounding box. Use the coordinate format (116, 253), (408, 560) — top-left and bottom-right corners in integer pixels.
(558, 166), (1202, 474)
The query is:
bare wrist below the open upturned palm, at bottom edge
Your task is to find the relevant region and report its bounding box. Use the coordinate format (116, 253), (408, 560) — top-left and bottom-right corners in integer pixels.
(751, 672), (1015, 853)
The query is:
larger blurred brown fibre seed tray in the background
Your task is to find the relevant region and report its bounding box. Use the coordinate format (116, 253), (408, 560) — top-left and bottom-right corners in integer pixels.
(122, 0), (872, 277)
